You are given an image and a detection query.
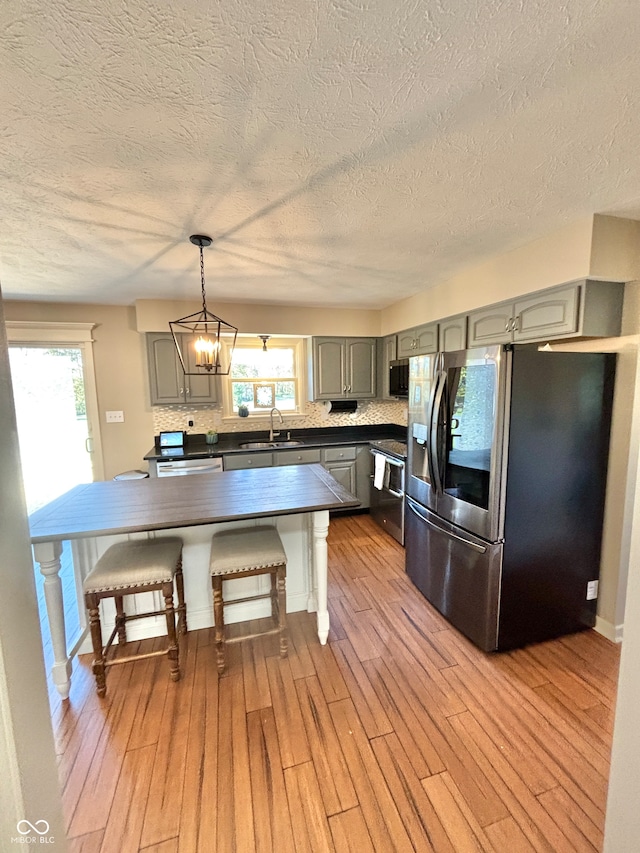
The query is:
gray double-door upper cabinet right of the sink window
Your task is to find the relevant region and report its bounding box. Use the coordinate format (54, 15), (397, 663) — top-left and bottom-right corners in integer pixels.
(311, 338), (376, 400)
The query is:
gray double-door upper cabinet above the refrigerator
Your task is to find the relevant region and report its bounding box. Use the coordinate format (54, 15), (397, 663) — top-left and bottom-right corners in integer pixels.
(467, 279), (624, 347)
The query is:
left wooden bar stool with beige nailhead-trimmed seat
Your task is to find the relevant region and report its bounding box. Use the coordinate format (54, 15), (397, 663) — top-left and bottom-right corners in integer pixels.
(83, 536), (187, 696)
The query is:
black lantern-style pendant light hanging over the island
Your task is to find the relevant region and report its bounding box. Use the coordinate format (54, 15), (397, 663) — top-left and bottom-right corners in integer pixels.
(169, 234), (238, 376)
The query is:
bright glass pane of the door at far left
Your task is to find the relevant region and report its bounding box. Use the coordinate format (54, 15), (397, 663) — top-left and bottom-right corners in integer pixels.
(9, 345), (94, 513)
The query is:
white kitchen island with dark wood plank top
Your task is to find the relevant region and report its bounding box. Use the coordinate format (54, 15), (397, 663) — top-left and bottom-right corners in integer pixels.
(29, 464), (358, 698)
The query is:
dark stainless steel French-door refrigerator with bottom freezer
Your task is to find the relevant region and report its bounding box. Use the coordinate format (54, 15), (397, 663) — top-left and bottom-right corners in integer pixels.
(405, 346), (615, 651)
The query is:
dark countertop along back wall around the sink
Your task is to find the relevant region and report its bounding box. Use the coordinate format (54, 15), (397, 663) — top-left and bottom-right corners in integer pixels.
(144, 424), (407, 460)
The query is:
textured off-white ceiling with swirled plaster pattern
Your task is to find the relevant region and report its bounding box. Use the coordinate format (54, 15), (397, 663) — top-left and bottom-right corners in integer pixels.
(0, 0), (640, 308)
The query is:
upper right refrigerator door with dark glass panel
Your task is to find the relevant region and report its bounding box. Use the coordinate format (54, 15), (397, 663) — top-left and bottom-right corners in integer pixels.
(434, 347), (505, 540)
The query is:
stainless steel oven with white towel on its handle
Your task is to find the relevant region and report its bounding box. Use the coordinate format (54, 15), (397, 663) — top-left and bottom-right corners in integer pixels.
(369, 441), (406, 545)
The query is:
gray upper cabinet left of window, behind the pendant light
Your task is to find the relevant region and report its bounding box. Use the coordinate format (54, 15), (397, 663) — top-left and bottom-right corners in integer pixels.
(147, 332), (218, 406)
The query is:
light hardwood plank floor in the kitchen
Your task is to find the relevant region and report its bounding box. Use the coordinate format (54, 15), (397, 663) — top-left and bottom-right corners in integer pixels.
(52, 516), (619, 853)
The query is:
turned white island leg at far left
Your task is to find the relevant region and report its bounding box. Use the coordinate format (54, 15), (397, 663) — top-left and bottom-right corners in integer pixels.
(33, 542), (71, 699)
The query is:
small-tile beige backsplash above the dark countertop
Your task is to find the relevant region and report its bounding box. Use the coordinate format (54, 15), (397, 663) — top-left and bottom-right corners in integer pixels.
(153, 400), (407, 435)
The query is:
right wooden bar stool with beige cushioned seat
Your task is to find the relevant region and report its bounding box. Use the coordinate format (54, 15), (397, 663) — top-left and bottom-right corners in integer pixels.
(209, 527), (287, 672)
